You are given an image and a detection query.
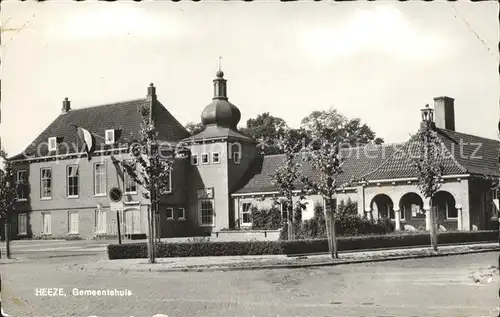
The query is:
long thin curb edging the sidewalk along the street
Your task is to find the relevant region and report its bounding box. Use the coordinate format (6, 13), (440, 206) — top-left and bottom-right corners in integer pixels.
(97, 247), (500, 273)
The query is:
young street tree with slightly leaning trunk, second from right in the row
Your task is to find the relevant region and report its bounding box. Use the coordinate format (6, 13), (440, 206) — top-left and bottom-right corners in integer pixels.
(302, 126), (342, 258)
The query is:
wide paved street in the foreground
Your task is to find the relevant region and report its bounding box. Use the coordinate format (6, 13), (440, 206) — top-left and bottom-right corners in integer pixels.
(0, 241), (499, 317)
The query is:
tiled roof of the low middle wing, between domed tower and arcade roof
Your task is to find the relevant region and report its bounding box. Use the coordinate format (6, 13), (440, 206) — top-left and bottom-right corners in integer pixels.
(235, 144), (396, 194)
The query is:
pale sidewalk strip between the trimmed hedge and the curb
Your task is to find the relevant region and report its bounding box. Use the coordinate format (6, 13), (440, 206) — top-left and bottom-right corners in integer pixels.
(60, 243), (500, 273)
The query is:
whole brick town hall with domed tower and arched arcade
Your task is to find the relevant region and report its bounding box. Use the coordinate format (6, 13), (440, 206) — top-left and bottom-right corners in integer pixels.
(6, 71), (500, 238)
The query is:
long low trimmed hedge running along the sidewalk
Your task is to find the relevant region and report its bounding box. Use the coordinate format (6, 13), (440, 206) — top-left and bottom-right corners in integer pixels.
(108, 231), (498, 260)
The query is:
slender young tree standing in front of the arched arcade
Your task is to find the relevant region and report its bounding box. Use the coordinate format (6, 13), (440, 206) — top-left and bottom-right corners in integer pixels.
(409, 105), (443, 251)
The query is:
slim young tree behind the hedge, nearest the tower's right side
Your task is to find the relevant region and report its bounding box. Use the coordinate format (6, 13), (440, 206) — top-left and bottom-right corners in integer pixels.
(270, 130), (302, 240)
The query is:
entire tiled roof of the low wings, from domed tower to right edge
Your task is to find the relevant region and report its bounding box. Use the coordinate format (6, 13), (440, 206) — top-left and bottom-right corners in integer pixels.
(234, 129), (500, 194)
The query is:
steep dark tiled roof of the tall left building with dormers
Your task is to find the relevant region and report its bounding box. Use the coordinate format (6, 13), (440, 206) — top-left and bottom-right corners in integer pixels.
(12, 98), (189, 160)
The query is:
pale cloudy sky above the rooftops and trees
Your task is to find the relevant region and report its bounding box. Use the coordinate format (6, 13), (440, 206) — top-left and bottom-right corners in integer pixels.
(0, 0), (500, 154)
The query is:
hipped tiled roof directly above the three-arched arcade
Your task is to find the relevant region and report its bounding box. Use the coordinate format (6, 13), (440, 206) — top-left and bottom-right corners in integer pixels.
(363, 129), (500, 180)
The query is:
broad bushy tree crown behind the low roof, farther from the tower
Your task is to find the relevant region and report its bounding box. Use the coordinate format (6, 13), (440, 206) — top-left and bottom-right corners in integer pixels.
(301, 108), (384, 146)
